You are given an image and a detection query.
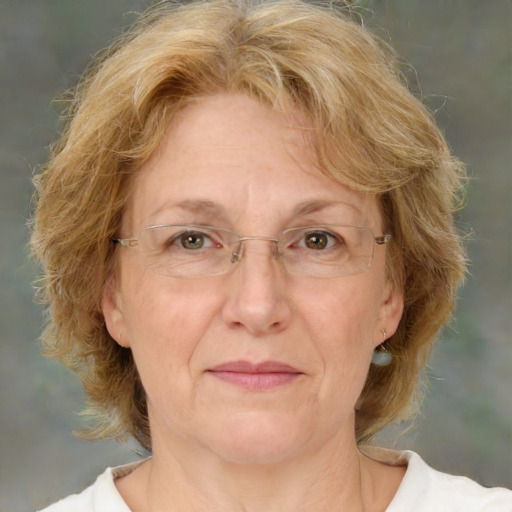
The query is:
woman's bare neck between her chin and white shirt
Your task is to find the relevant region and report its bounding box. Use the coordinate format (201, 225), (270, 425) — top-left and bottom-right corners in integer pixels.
(138, 426), (373, 512)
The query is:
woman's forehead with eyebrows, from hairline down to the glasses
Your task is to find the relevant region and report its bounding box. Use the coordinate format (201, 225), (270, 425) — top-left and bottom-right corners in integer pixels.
(124, 94), (379, 230)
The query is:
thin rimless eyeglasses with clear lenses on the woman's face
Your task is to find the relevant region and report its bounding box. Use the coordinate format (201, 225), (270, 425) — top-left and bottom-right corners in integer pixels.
(112, 224), (391, 278)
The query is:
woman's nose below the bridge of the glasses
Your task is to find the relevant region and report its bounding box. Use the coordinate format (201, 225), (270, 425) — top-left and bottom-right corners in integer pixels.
(223, 237), (292, 336)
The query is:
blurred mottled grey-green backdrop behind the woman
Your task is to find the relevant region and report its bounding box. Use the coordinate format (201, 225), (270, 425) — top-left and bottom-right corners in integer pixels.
(0, 0), (512, 512)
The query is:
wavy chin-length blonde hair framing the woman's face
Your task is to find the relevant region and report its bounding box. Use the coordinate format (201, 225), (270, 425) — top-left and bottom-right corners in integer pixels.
(32, 0), (465, 449)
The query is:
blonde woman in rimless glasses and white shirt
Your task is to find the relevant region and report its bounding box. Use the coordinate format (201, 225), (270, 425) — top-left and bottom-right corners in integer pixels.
(32, 0), (512, 512)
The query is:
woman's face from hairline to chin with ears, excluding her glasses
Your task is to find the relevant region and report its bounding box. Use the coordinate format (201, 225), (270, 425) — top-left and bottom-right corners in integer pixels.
(103, 94), (402, 462)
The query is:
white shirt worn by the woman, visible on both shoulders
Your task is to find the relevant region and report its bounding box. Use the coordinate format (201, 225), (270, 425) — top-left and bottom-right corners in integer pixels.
(41, 447), (512, 512)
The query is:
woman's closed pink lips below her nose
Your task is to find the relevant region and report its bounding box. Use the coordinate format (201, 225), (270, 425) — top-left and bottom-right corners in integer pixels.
(208, 361), (303, 391)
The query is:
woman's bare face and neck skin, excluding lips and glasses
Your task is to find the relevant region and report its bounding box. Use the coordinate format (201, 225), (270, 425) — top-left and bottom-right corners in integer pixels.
(103, 94), (404, 512)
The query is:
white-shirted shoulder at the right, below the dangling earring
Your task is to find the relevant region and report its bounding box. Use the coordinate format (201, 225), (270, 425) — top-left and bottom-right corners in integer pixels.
(369, 449), (512, 512)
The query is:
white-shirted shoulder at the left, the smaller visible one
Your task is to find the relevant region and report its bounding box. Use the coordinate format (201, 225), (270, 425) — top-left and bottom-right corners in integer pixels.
(40, 462), (141, 512)
